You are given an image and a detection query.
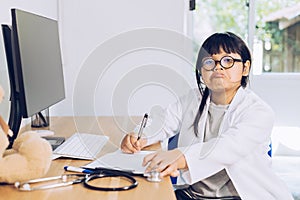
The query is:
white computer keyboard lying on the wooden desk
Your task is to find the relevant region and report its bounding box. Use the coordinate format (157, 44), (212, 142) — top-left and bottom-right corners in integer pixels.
(53, 133), (109, 160)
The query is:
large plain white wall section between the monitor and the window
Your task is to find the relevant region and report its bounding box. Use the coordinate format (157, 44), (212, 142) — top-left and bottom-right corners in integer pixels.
(52, 0), (195, 115)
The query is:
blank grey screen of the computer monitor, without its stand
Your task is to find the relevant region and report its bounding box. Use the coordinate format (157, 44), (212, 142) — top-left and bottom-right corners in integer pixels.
(12, 9), (65, 117)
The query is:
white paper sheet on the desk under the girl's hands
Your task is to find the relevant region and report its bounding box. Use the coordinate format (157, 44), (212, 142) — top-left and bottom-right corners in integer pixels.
(83, 149), (153, 174)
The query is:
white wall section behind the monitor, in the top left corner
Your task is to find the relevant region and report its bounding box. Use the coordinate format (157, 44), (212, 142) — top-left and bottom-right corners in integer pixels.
(0, 0), (58, 119)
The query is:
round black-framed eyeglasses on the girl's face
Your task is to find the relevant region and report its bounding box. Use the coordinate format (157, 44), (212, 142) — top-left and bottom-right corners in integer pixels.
(202, 56), (243, 71)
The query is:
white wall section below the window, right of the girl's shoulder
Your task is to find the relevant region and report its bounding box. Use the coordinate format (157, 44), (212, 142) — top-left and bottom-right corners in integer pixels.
(250, 73), (300, 127)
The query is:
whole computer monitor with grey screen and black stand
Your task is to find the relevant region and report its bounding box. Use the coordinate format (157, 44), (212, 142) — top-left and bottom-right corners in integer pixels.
(2, 9), (65, 147)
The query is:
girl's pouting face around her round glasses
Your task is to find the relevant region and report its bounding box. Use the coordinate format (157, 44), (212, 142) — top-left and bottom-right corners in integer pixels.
(201, 50), (250, 93)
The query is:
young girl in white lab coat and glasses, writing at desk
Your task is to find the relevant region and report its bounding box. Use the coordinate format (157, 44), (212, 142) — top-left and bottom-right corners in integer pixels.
(121, 32), (293, 200)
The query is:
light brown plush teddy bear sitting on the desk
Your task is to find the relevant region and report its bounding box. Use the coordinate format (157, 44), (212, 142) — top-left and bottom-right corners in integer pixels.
(0, 86), (52, 183)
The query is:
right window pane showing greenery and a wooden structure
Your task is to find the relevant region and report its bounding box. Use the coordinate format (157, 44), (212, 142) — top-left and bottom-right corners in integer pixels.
(255, 0), (300, 72)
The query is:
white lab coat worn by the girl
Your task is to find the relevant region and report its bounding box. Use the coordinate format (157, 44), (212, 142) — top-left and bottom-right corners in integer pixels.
(144, 88), (293, 200)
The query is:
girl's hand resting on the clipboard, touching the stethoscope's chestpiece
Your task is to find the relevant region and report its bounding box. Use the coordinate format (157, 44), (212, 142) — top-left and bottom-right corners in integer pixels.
(143, 149), (187, 177)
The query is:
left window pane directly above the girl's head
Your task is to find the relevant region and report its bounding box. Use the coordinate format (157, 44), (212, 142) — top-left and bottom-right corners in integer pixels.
(193, 0), (248, 49)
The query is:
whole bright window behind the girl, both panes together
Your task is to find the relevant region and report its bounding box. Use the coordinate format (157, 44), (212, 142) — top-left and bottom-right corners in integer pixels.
(193, 0), (300, 75)
